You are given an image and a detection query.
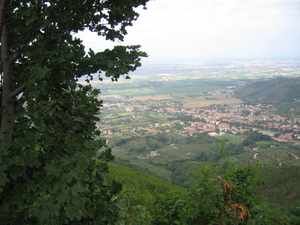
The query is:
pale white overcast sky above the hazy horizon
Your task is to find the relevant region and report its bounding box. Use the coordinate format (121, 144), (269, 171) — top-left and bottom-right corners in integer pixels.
(80, 0), (300, 63)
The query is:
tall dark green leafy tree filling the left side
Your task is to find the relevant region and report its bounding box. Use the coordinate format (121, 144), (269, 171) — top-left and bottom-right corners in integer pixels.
(0, 0), (148, 225)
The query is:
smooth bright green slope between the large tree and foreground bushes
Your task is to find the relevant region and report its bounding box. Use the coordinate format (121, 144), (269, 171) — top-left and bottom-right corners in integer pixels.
(110, 164), (185, 225)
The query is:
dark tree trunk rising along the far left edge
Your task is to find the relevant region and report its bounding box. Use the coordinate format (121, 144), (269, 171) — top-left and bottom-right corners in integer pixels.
(0, 18), (15, 148)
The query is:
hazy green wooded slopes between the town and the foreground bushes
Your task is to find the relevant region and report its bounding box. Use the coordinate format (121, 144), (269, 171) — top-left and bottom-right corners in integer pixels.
(113, 132), (300, 214)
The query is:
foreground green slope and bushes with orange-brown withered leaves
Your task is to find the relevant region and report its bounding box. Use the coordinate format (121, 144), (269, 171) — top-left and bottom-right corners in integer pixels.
(110, 161), (298, 225)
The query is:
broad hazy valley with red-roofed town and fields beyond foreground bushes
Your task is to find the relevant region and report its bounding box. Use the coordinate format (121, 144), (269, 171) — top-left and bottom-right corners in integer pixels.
(99, 62), (300, 209)
